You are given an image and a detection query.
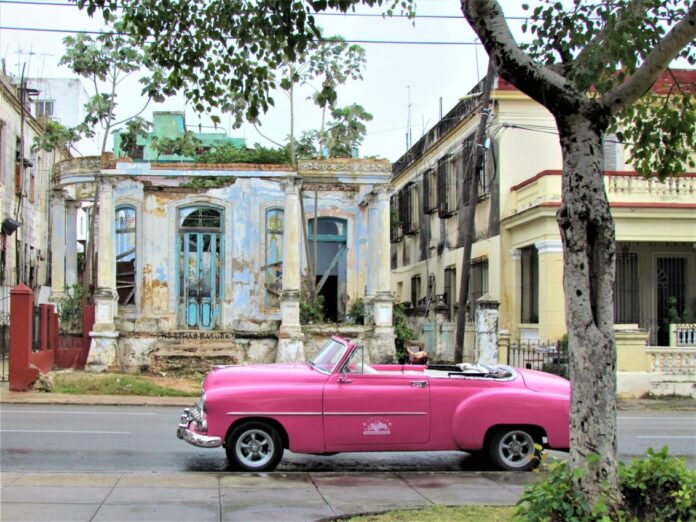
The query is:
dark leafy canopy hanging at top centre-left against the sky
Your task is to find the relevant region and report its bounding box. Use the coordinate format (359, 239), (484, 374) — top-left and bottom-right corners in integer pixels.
(77, 0), (413, 127)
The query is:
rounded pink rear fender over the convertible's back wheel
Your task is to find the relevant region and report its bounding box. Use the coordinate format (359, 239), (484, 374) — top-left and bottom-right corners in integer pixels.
(452, 388), (570, 450)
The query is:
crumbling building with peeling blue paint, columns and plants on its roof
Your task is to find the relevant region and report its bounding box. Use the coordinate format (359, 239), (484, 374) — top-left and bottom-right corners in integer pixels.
(52, 156), (394, 371)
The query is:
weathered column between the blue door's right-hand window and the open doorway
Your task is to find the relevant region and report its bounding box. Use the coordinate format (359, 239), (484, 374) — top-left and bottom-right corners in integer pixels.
(276, 178), (305, 363)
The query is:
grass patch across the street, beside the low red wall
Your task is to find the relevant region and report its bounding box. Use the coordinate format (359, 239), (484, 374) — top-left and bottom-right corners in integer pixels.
(53, 372), (200, 397)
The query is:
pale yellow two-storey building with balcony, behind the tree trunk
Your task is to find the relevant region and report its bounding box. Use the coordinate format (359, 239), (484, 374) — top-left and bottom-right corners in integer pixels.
(391, 71), (696, 358)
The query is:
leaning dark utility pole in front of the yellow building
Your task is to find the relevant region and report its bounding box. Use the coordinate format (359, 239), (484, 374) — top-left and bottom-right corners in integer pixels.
(454, 61), (495, 362)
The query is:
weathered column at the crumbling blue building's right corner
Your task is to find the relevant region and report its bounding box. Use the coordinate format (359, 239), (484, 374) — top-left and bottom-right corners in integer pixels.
(369, 185), (396, 362)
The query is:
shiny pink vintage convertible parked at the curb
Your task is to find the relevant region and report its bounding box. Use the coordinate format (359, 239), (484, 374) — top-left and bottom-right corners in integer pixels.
(177, 337), (570, 471)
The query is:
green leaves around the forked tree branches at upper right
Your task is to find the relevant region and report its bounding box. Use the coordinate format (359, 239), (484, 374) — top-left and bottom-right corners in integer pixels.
(521, 0), (696, 180)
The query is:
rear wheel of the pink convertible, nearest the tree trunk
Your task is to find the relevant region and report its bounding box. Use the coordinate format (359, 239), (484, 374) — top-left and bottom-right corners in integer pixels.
(488, 427), (541, 471)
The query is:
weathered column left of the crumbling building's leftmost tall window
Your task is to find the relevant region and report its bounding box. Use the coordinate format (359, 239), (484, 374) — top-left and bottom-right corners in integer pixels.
(86, 179), (118, 372)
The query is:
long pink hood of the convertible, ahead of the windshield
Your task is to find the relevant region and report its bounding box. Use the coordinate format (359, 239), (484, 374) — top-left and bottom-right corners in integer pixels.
(203, 364), (320, 390)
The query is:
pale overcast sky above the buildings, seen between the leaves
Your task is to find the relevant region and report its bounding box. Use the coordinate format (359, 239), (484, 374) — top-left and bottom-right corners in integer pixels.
(0, 0), (524, 161)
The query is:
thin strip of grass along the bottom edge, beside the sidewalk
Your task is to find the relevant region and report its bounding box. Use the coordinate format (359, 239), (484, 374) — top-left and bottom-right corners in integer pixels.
(349, 506), (516, 522)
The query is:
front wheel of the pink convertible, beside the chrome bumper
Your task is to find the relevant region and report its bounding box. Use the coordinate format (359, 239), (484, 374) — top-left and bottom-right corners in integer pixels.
(225, 422), (283, 471)
